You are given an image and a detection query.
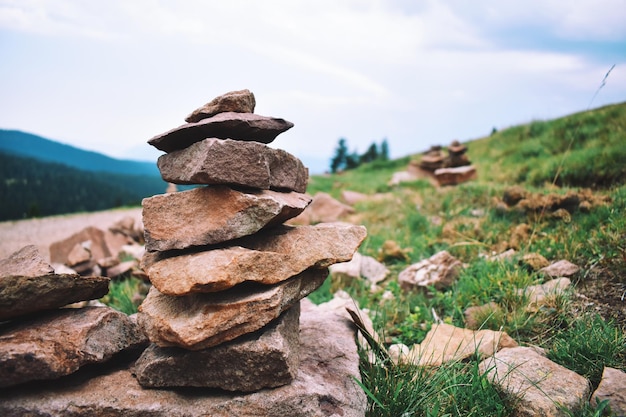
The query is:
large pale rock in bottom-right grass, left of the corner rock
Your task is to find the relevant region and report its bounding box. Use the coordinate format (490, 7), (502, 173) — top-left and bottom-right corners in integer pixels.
(479, 347), (590, 417)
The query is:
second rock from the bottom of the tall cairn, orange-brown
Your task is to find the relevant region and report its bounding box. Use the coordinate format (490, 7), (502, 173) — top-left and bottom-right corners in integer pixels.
(137, 269), (328, 350)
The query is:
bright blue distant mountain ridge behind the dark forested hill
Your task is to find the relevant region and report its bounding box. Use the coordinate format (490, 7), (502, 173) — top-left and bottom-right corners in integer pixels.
(0, 129), (160, 177)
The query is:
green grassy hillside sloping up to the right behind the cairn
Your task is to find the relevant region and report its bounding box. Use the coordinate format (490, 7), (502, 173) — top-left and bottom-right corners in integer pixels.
(103, 103), (626, 417)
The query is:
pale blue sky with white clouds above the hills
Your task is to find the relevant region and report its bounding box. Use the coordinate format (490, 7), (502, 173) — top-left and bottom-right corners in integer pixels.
(0, 0), (626, 173)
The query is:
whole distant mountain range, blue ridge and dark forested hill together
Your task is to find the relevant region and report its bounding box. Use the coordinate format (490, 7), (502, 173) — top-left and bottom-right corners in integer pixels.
(0, 130), (171, 221)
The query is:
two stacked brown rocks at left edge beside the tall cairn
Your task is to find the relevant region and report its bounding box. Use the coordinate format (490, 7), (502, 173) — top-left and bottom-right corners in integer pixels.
(0, 245), (147, 386)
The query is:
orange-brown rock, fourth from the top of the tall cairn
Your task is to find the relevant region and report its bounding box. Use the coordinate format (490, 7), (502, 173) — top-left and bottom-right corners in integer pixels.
(142, 185), (311, 251)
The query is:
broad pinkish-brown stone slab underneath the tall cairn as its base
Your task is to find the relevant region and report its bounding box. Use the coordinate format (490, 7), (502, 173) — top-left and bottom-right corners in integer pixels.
(0, 300), (367, 417)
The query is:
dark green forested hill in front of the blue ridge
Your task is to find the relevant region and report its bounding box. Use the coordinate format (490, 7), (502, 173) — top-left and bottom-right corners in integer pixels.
(0, 151), (167, 221)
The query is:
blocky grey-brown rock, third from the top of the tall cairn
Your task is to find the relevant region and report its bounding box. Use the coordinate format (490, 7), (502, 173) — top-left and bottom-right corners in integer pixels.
(157, 138), (309, 193)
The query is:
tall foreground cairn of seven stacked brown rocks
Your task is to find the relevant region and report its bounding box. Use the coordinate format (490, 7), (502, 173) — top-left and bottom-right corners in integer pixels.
(133, 90), (366, 392)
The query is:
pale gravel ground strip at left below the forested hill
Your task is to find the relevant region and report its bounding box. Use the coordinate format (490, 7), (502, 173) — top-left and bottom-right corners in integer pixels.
(0, 207), (141, 261)
